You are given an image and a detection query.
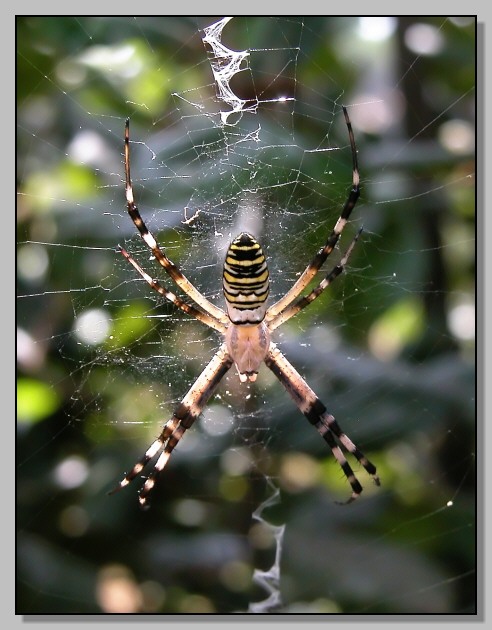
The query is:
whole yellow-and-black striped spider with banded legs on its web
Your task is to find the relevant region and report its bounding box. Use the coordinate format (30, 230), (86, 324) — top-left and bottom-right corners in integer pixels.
(110, 107), (380, 508)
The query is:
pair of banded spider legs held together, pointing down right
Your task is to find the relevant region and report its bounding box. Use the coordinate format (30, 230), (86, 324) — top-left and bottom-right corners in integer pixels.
(265, 343), (380, 503)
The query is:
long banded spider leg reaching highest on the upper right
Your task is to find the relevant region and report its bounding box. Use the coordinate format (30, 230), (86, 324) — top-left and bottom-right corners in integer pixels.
(265, 107), (360, 324)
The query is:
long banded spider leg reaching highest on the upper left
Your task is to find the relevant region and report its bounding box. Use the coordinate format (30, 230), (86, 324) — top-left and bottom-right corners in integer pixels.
(125, 118), (228, 324)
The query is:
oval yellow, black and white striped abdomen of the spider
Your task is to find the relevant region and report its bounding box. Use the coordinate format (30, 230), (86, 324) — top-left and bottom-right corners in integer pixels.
(222, 232), (270, 324)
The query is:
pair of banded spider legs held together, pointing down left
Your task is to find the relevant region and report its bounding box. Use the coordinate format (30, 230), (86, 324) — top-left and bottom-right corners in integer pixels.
(109, 344), (233, 508)
